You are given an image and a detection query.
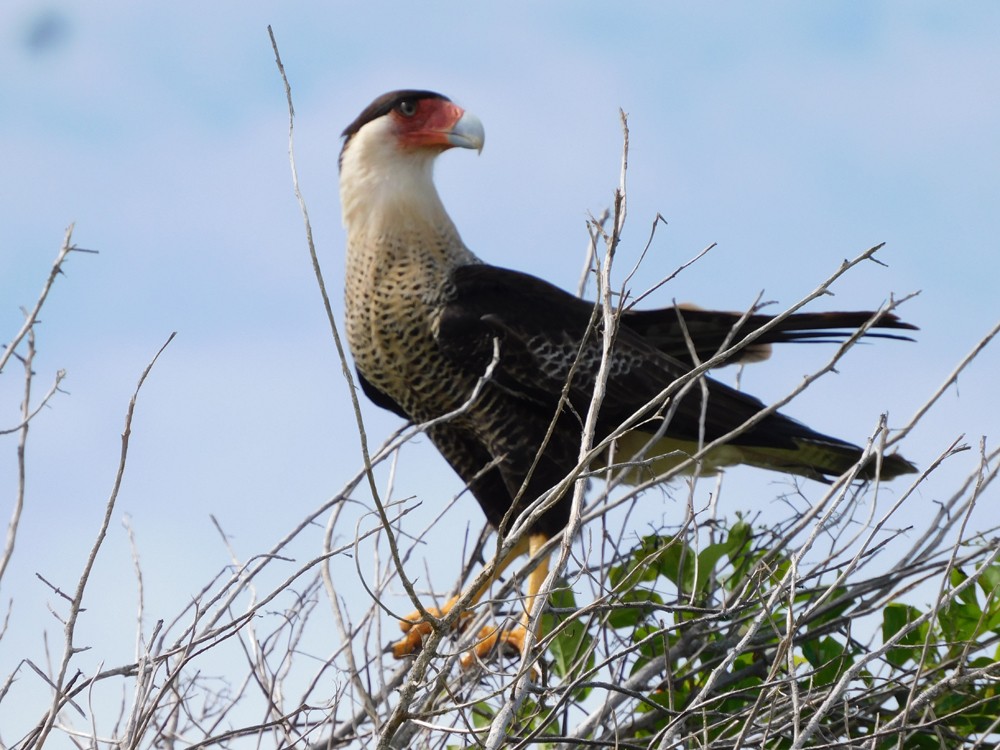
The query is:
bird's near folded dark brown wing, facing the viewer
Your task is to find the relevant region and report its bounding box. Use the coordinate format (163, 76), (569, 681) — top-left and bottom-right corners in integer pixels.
(438, 265), (912, 476)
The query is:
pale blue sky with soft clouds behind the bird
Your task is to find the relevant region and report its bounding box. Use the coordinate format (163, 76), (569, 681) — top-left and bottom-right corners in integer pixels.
(0, 0), (1000, 741)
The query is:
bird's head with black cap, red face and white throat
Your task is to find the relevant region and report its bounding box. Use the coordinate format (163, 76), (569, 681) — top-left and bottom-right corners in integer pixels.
(340, 90), (485, 231)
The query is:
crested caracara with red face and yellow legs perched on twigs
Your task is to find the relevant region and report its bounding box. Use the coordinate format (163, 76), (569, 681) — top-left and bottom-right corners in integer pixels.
(339, 89), (916, 663)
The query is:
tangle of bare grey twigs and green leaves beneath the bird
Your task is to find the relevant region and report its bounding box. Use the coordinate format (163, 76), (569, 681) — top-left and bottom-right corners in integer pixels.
(0, 63), (1000, 750)
